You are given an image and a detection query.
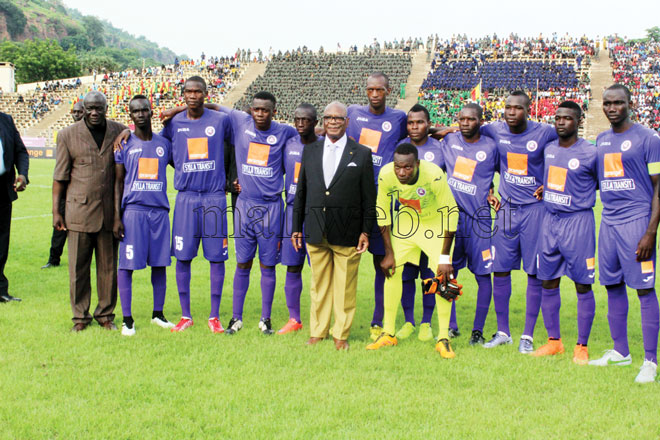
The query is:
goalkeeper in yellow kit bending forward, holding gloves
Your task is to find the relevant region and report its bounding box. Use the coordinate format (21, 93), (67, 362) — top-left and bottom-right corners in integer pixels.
(367, 143), (458, 359)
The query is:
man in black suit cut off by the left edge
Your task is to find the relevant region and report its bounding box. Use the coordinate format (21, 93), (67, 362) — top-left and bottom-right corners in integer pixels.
(0, 113), (30, 302)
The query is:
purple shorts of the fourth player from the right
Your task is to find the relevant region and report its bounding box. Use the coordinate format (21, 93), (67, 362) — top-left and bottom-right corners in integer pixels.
(452, 211), (493, 276)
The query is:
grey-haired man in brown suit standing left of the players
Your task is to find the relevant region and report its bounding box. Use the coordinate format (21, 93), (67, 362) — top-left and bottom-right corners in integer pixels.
(53, 91), (126, 332)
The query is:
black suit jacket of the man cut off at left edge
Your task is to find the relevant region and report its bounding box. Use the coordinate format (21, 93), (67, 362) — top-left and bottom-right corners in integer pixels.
(0, 112), (30, 202)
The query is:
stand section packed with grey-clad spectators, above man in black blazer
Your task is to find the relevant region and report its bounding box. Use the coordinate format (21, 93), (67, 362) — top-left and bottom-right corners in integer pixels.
(235, 51), (411, 122)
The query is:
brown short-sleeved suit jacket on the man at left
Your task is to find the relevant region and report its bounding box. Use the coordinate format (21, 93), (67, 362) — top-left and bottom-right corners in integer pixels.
(53, 119), (126, 233)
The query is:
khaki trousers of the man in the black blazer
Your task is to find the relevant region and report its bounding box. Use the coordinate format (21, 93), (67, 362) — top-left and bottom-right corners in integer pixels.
(307, 238), (360, 340)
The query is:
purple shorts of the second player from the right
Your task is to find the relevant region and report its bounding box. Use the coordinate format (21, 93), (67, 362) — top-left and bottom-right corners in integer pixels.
(537, 209), (596, 284)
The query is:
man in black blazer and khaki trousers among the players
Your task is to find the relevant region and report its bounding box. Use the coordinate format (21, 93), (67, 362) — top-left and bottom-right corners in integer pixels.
(291, 102), (376, 350)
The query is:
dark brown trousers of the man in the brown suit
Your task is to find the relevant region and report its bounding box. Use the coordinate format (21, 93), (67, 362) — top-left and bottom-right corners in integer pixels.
(68, 229), (117, 324)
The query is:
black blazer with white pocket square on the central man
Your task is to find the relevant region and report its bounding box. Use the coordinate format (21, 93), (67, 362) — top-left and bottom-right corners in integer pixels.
(293, 139), (376, 246)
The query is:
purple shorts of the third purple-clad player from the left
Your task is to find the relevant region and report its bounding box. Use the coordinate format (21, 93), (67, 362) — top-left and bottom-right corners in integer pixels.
(234, 195), (284, 266)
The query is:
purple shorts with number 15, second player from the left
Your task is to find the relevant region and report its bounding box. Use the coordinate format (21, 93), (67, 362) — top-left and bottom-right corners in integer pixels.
(172, 191), (229, 263)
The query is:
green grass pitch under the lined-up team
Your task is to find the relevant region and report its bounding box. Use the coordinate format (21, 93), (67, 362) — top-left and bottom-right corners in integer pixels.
(0, 160), (660, 439)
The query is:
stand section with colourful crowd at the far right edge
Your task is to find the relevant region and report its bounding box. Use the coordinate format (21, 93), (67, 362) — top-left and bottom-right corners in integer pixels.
(610, 42), (660, 130)
